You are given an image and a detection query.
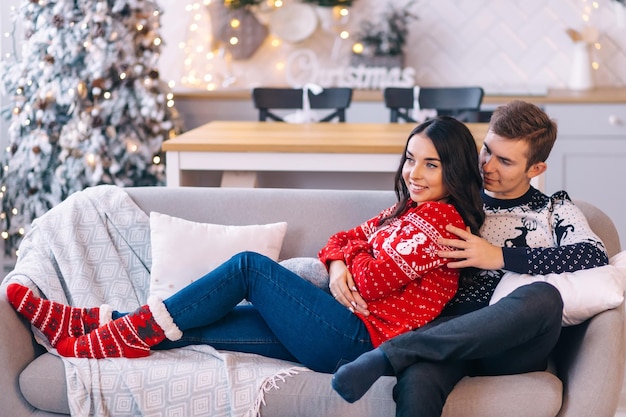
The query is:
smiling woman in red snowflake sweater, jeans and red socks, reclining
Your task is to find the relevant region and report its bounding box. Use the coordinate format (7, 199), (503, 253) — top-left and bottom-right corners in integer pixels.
(7, 117), (484, 372)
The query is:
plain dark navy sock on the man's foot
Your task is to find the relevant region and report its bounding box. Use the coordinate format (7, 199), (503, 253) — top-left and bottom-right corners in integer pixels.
(332, 349), (393, 403)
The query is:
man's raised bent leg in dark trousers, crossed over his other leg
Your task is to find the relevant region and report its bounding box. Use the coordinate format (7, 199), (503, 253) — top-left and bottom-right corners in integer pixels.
(379, 282), (563, 368)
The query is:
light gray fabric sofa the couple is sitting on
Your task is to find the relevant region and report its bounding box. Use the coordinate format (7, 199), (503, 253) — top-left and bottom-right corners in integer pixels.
(0, 187), (624, 417)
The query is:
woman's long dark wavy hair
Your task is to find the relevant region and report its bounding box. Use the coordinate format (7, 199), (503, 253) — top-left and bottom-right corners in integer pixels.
(385, 116), (485, 235)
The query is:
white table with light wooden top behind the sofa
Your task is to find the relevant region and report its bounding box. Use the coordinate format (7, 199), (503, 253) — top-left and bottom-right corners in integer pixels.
(162, 121), (488, 187)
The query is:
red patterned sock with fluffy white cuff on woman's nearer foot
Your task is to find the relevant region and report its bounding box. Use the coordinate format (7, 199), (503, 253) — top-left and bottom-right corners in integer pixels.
(57, 298), (182, 359)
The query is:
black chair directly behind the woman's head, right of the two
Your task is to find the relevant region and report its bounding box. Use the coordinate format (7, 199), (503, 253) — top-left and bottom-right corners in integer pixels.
(383, 87), (485, 123)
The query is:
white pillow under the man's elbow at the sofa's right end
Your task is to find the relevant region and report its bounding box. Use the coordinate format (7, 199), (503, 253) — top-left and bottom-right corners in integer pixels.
(489, 265), (624, 326)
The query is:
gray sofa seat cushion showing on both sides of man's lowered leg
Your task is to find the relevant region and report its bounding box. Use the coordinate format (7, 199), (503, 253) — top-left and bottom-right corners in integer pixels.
(261, 372), (563, 417)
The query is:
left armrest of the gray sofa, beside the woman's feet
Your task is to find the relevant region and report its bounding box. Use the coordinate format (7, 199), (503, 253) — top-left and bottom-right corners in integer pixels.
(0, 285), (43, 417)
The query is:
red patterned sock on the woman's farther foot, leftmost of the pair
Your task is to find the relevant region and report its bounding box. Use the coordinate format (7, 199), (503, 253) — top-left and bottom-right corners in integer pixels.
(7, 283), (112, 347)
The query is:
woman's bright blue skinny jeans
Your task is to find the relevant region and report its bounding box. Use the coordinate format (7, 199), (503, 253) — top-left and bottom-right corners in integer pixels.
(116, 252), (373, 373)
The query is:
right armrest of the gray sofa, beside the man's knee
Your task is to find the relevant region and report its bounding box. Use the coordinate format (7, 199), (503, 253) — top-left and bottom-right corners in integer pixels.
(554, 303), (625, 417)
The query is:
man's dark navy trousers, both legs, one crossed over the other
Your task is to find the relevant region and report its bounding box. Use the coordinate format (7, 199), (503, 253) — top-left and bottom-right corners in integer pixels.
(380, 282), (563, 417)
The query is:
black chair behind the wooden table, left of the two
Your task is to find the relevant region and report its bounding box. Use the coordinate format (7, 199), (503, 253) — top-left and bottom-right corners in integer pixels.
(252, 87), (352, 122)
